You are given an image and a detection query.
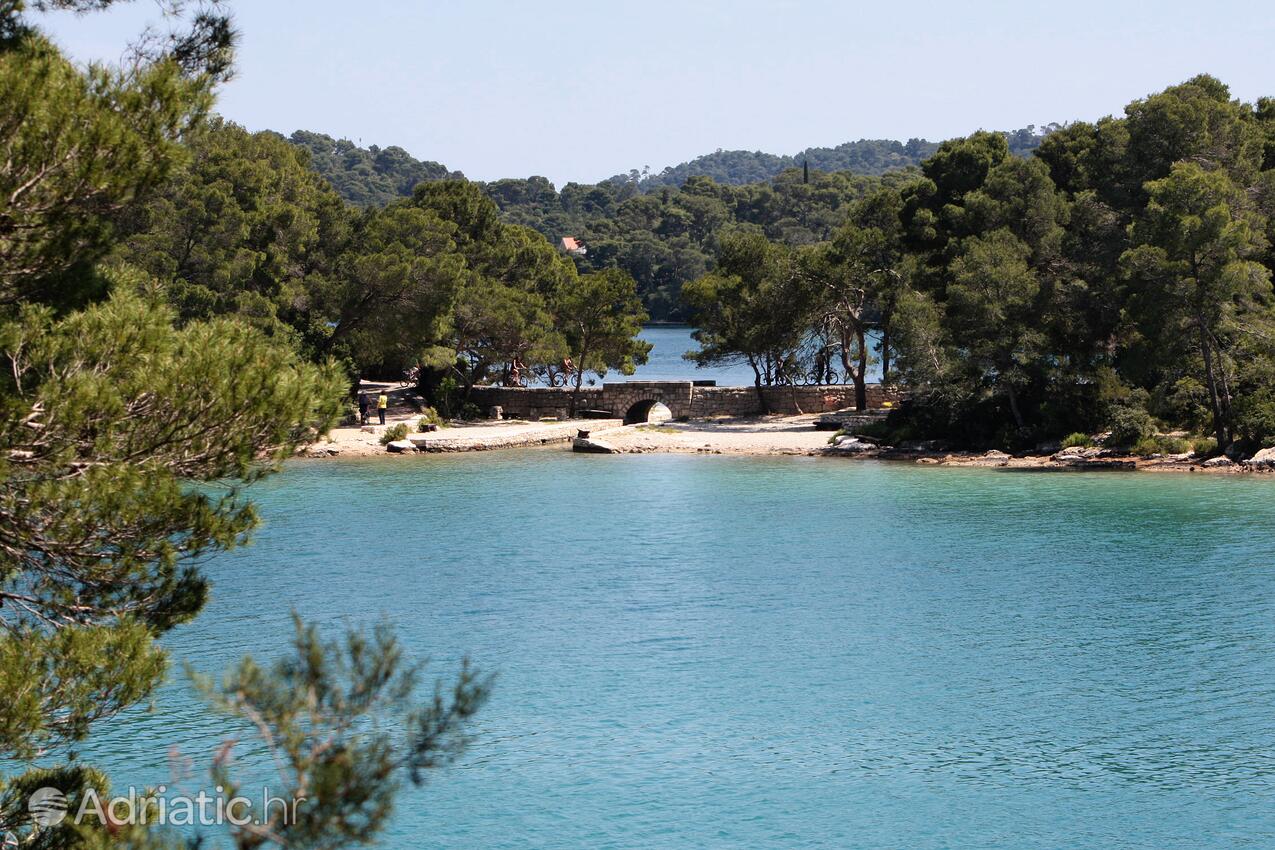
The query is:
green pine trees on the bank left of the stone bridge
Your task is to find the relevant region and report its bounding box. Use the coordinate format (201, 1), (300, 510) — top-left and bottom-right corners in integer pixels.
(112, 117), (648, 413)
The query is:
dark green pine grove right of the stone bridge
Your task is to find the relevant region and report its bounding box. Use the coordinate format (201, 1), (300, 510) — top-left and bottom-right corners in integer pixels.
(683, 76), (1275, 451)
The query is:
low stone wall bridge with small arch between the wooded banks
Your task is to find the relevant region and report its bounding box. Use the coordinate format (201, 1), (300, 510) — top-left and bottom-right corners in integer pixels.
(469, 381), (896, 423)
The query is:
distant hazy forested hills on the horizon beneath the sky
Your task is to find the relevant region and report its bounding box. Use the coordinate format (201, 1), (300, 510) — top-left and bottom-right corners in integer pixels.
(289, 125), (1057, 321)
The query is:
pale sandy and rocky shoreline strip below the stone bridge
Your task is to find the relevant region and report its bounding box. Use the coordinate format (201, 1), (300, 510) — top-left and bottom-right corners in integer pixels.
(298, 413), (1272, 475)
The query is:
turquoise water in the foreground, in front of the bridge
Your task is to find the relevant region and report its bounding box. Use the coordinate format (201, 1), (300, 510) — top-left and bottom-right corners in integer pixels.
(77, 450), (1275, 850)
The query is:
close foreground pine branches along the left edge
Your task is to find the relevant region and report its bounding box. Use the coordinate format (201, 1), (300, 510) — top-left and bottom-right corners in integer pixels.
(0, 0), (488, 850)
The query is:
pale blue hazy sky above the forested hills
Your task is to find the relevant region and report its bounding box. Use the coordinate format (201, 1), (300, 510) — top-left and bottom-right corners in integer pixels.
(43, 0), (1275, 185)
